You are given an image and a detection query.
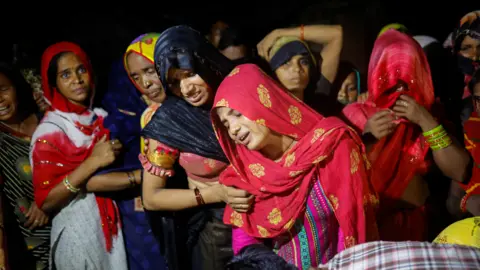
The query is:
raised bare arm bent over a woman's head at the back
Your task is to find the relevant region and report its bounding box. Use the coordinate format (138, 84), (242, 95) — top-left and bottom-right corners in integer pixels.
(268, 25), (343, 83)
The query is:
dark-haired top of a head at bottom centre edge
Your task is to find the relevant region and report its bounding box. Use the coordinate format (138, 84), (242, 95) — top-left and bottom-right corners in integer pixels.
(225, 244), (298, 270)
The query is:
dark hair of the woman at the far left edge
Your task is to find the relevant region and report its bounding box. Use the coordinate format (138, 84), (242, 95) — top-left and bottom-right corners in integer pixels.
(0, 62), (38, 116)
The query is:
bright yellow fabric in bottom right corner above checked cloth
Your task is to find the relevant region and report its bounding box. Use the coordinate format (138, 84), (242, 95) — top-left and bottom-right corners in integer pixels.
(433, 216), (480, 248)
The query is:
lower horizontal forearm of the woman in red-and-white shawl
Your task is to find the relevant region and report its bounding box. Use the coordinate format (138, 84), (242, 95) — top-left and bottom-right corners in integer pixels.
(86, 170), (142, 192)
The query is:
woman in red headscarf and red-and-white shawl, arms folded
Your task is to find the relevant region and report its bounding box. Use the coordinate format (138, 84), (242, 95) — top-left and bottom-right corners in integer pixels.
(30, 42), (128, 270)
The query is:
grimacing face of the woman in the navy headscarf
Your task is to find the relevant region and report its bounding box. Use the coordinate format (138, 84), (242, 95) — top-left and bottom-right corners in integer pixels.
(167, 68), (213, 107)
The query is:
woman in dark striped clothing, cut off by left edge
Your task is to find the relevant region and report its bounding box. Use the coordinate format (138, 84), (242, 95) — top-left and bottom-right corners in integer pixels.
(0, 63), (50, 269)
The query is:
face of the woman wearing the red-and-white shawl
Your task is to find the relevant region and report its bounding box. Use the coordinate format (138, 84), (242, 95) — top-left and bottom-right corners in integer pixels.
(57, 53), (91, 105)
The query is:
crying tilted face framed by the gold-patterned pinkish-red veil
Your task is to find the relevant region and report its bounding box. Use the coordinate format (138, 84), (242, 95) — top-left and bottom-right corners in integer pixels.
(216, 107), (272, 151)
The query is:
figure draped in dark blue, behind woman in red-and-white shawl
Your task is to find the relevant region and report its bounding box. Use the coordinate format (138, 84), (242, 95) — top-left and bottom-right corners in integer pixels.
(101, 55), (167, 270)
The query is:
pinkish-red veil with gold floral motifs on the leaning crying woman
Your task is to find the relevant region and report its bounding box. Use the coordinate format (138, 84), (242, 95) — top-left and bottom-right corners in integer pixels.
(212, 64), (376, 243)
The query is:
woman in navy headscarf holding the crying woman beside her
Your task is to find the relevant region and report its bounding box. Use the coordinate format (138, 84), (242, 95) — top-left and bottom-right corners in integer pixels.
(140, 26), (250, 269)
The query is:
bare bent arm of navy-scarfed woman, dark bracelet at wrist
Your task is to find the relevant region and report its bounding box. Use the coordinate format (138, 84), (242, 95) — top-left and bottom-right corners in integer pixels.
(142, 139), (222, 211)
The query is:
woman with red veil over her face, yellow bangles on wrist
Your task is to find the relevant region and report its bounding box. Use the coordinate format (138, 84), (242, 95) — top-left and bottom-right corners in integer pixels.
(344, 30), (470, 241)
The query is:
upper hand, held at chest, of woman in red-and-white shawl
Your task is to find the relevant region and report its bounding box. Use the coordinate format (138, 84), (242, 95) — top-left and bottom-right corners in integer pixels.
(90, 136), (122, 168)
